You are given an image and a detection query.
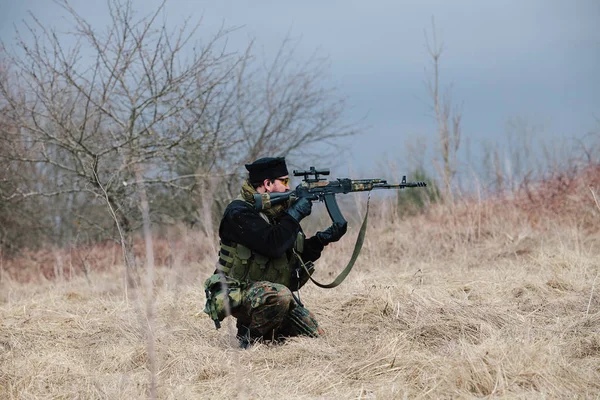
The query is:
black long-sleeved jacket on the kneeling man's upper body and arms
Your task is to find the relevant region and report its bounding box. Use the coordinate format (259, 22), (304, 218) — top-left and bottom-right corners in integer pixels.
(219, 200), (324, 262)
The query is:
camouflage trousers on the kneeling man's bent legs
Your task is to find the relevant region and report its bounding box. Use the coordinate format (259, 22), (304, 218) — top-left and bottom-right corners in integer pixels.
(232, 281), (325, 340)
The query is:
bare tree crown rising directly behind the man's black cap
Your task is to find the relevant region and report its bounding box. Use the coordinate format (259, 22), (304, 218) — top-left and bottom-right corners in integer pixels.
(230, 37), (355, 160)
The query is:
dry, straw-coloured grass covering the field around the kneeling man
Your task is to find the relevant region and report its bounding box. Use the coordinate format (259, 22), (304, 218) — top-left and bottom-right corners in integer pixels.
(0, 170), (600, 399)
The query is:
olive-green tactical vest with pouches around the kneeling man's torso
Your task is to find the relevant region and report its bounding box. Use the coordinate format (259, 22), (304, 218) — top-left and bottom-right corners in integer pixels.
(217, 203), (304, 287)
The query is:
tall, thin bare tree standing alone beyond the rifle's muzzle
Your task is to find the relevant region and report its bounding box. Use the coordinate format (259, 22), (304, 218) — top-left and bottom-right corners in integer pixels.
(425, 19), (462, 197)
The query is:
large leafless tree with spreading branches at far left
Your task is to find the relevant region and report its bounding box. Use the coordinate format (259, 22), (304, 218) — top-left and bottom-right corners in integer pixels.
(0, 0), (246, 272)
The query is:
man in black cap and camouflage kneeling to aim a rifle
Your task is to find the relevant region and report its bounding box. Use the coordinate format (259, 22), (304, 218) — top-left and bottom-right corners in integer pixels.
(205, 157), (347, 348)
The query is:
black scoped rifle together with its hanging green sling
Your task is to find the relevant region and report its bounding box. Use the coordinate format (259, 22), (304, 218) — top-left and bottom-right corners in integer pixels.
(254, 167), (427, 289)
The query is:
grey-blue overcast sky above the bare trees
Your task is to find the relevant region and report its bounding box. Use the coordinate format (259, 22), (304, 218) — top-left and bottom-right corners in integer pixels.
(0, 0), (600, 175)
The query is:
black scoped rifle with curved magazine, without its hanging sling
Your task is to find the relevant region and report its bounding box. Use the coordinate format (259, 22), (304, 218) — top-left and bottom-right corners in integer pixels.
(254, 167), (427, 224)
